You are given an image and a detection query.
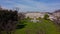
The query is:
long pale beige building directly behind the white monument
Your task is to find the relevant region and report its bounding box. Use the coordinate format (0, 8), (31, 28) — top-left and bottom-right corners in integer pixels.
(25, 12), (46, 18)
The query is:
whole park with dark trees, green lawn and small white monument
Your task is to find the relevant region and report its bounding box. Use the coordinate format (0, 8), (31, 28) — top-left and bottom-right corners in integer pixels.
(0, 10), (60, 34)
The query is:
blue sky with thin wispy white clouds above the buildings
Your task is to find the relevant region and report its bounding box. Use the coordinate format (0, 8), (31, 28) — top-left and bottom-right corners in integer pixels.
(0, 0), (60, 12)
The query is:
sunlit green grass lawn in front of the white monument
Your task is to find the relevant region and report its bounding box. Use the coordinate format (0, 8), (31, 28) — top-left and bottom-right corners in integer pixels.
(15, 20), (60, 34)
